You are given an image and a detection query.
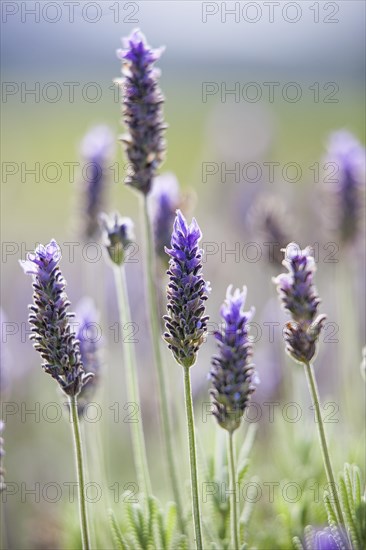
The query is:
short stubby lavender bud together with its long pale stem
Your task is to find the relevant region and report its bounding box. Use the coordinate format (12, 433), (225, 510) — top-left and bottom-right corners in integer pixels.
(101, 214), (151, 495)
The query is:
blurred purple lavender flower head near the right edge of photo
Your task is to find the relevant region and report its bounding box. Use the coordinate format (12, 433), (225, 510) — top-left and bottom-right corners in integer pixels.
(325, 130), (366, 243)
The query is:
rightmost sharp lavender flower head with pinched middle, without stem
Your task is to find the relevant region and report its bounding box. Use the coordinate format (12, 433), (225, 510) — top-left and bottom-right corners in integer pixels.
(273, 243), (326, 363)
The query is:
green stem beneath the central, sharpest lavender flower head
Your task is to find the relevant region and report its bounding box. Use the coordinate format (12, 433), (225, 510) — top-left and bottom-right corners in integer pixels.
(183, 367), (203, 550)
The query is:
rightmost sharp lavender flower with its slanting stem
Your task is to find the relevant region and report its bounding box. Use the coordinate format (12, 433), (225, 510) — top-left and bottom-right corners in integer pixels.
(273, 243), (345, 525)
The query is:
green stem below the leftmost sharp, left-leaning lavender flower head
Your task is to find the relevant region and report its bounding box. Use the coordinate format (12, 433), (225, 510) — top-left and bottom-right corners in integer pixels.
(69, 396), (90, 550)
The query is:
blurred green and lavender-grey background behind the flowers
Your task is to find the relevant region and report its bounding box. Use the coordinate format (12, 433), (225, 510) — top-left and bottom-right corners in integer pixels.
(1, 1), (365, 549)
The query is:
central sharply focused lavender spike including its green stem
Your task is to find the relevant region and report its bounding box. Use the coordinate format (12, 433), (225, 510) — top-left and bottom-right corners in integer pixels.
(164, 210), (209, 549)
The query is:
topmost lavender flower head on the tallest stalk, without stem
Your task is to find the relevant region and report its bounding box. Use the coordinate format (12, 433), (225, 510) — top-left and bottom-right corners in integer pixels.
(116, 30), (166, 195)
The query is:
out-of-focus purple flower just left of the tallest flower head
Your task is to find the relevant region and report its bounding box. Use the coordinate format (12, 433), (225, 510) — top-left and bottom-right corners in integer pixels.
(81, 126), (114, 244)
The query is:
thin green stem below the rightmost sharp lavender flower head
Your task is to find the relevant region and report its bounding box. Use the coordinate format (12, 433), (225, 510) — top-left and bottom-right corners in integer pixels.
(304, 363), (345, 525)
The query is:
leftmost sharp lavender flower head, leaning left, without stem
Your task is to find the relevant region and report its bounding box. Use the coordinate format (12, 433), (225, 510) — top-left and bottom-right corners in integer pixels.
(20, 240), (93, 396)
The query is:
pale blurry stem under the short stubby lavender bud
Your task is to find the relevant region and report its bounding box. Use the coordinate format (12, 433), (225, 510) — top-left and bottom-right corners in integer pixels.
(114, 266), (152, 496)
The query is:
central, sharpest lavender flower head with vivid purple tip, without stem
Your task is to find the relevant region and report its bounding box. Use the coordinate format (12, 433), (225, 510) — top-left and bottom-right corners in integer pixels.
(164, 210), (209, 368)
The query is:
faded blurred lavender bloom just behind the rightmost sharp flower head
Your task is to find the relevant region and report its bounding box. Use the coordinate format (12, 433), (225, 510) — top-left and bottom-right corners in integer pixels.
(248, 195), (293, 266)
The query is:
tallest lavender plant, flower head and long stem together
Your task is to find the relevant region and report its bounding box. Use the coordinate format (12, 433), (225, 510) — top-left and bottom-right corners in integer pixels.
(116, 30), (185, 533)
